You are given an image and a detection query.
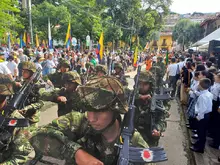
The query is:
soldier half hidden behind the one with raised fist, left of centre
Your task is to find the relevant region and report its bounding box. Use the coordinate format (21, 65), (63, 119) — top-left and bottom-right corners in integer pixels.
(43, 59), (70, 88)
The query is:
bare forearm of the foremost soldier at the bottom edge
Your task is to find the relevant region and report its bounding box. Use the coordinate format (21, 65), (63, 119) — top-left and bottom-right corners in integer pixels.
(75, 149), (104, 165)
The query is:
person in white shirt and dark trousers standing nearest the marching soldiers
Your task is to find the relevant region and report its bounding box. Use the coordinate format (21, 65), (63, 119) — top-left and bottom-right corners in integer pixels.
(167, 57), (177, 97)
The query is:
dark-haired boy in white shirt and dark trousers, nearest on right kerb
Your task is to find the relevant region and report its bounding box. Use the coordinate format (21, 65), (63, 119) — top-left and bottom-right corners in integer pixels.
(190, 78), (213, 153)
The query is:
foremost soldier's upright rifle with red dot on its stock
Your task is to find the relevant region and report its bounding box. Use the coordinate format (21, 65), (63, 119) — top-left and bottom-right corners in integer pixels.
(116, 65), (167, 165)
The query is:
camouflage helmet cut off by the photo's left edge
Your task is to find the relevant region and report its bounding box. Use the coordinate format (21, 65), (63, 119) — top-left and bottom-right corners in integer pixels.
(0, 73), (14, 96)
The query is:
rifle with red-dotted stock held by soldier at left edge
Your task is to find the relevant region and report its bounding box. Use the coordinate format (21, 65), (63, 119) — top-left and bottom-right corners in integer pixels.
(0, 66), (41, 161)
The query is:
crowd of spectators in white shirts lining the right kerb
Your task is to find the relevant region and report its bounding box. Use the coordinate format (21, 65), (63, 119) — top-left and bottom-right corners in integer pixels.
(167, 53), (220, 158)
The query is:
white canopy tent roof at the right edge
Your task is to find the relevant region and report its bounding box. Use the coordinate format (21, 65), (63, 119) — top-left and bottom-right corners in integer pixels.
(192, 28), (220, 47)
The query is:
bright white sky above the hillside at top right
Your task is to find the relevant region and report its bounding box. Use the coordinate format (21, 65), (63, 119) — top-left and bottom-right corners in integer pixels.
(171, 0), (220, 14)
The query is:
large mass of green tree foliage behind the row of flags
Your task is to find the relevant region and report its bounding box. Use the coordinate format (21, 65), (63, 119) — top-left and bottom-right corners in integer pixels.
(6, 0), (171, 46)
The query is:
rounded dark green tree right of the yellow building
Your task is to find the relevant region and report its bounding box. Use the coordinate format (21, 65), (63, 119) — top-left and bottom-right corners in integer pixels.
(173, 19), (203, 46)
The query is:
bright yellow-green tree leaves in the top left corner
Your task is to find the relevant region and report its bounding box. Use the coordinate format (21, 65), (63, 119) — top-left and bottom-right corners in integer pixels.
(0, 0), (23, 38)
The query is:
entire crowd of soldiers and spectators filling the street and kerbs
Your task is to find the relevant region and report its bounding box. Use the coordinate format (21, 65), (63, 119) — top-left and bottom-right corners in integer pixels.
(0, 43), (220, 165)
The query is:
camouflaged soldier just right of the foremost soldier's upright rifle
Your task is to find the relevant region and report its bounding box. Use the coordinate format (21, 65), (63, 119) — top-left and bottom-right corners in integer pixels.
(135, 71), (166, 147)
